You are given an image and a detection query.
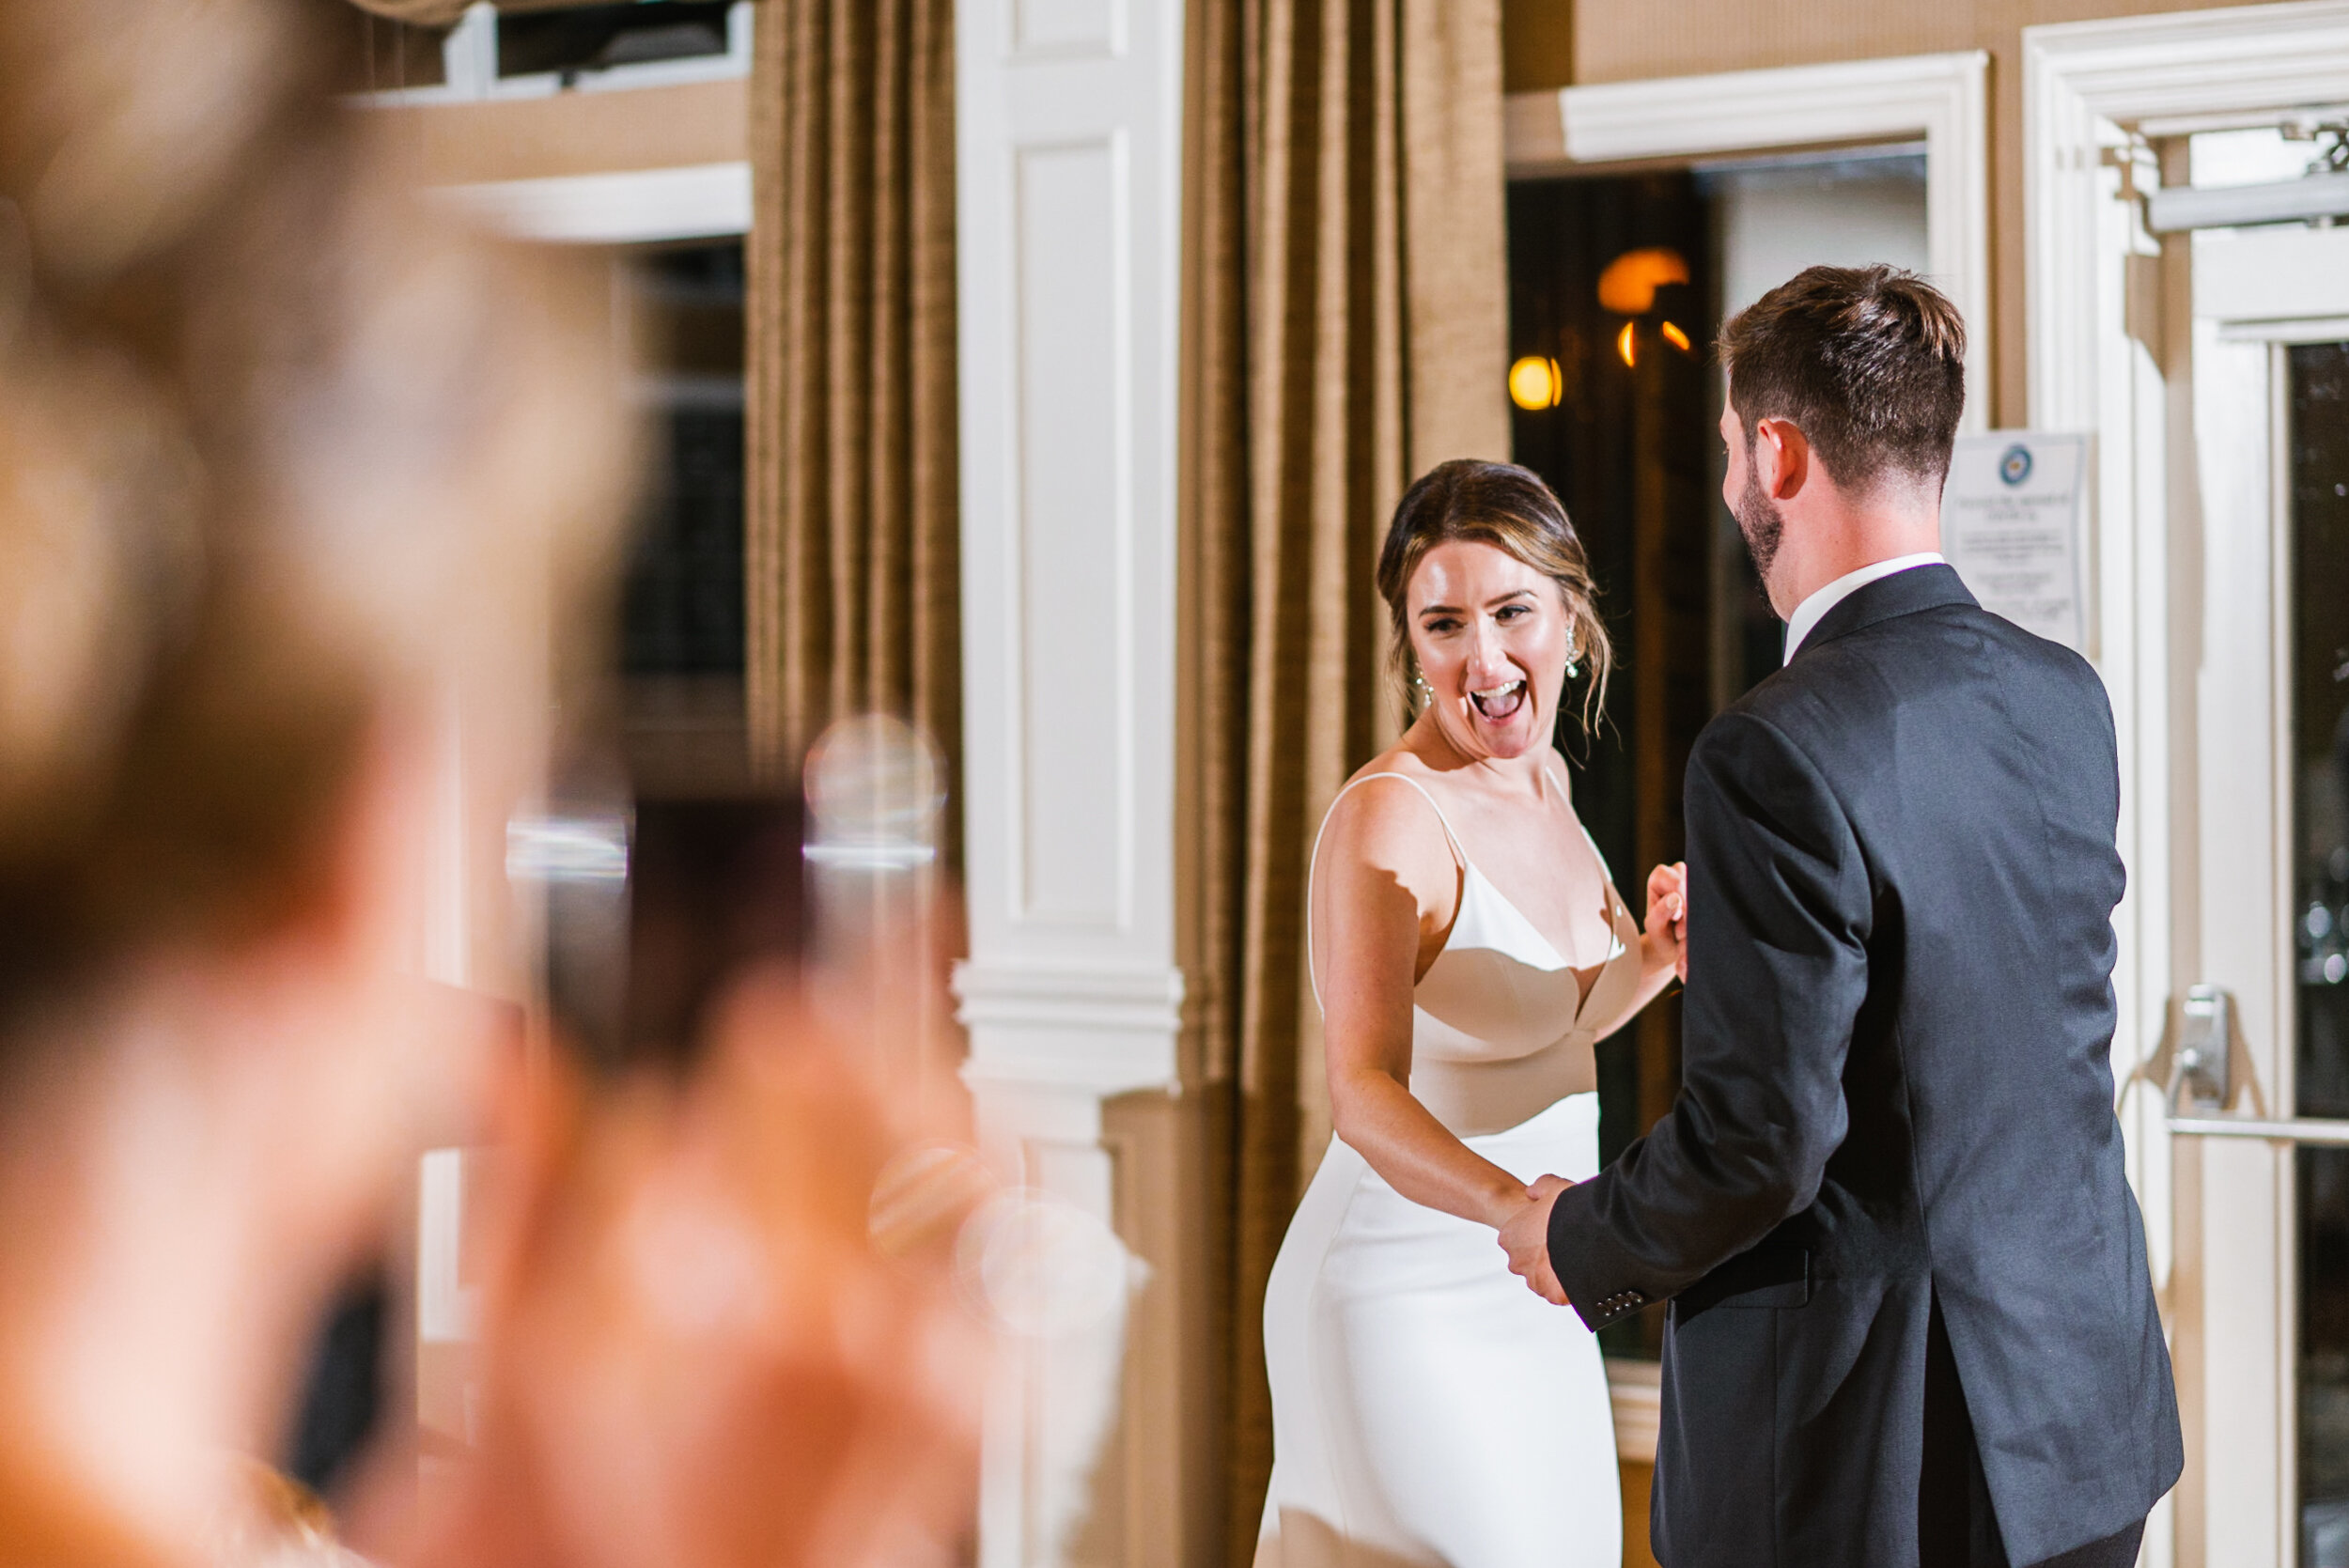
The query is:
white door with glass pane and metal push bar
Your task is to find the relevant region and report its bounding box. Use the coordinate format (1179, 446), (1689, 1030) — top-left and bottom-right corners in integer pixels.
(2166, 201), (2349, 1568)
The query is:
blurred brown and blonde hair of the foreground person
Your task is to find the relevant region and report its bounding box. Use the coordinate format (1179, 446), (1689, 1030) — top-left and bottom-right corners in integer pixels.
(0, 0), (632, 1018)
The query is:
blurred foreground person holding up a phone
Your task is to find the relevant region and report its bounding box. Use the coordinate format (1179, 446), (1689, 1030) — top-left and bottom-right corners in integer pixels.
(0, 0), (980, 1568)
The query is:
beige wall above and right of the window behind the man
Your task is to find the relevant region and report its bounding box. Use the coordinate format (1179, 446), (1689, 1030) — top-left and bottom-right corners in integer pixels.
(1501, 0), (2283, 425)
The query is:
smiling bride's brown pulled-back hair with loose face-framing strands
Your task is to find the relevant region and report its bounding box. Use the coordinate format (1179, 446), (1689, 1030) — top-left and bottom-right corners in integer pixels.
(1379, 458), (1614, 735)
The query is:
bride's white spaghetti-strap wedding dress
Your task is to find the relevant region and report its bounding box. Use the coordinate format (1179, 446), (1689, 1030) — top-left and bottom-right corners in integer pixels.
(1257, 772), (1640, 1568)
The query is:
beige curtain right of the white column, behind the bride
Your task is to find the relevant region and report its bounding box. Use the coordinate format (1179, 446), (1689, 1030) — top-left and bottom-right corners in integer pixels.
(1184, 0), (1508, 1563)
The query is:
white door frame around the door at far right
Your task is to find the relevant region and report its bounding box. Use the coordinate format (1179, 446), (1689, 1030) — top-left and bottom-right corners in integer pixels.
(2023, 0), (2349, 1568)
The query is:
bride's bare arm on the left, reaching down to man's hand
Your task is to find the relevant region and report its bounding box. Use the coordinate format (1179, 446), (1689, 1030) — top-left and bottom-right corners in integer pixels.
(1314, 784), (1530, 1228)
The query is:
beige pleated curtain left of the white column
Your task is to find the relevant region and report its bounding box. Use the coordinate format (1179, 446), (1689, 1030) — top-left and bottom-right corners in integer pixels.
(745, 0), (961, 849)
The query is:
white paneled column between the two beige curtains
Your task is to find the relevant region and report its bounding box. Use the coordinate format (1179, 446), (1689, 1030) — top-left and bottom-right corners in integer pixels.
(957, 0), (1184, 1568)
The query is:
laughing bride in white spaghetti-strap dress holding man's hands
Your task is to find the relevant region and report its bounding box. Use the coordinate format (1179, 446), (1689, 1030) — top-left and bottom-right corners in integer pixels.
(1257, 460), (1685, 1568)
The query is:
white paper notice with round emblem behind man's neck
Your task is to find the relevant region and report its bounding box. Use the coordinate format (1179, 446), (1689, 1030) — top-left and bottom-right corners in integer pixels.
(1940, 429), (2089, 650)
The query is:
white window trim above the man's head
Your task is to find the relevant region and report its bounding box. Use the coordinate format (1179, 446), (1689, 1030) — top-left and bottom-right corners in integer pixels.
(1508, 49), (1990, 429)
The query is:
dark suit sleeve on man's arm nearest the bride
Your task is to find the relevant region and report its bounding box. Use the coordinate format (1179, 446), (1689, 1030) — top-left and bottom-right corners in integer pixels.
(1550, 714), (1873, 1328)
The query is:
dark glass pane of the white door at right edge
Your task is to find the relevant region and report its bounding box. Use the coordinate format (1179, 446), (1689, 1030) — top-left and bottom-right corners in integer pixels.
(2288, 343), (2349, 1568)
